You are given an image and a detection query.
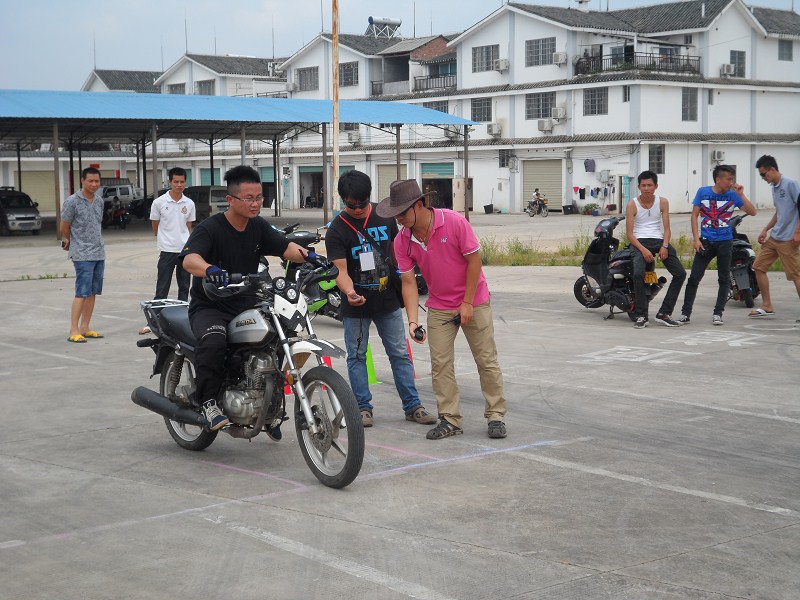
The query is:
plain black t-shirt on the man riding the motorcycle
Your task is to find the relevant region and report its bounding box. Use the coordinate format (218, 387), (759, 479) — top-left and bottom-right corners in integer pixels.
(181, 213), (289, 315)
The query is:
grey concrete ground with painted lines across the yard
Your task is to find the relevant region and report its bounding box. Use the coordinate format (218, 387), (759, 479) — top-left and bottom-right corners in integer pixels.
(0, 211), (800, 600)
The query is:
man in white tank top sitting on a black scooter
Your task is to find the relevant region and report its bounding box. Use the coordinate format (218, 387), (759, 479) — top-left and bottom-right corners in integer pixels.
(625, 171), (686, 329)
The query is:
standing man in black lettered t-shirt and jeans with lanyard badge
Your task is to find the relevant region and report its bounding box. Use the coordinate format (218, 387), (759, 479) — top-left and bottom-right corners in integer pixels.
(325, 171), (436, 427)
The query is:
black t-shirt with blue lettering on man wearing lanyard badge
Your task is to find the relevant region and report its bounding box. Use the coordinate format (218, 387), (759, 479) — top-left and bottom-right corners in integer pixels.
(325, 204), (400, 317)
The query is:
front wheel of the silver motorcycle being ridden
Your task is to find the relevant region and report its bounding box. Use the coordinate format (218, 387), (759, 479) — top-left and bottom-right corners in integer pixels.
(294, 366), (364, 488)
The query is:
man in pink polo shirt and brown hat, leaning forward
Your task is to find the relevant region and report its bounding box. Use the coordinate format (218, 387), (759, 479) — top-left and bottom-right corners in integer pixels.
(376, 179), (506, 440)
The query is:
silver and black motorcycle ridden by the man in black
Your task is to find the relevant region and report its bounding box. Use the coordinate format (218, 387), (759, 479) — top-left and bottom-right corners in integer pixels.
(131, 257), (364, 488)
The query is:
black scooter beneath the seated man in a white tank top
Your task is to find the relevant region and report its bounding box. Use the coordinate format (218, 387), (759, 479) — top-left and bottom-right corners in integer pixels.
(573, 217), (667, 321)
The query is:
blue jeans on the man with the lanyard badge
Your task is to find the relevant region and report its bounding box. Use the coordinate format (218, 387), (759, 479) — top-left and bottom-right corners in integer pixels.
(344, 308), (420, 414)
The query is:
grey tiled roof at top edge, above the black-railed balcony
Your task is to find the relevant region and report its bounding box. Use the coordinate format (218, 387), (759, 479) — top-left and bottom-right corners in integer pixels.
(508, 0), (733, 33)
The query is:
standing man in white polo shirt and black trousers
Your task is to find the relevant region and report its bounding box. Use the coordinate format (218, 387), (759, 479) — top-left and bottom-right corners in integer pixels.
(150, 167), (196, 301)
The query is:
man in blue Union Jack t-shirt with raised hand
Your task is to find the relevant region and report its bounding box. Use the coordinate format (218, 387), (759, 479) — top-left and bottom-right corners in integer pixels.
(678, 165), (756, 325)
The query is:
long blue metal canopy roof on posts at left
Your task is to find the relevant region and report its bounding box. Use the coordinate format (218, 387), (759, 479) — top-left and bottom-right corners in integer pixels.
(0, 90), (473, 143)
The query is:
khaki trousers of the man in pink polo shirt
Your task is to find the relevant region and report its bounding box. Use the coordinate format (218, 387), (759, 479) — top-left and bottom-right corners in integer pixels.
(428, 302), (506, 427)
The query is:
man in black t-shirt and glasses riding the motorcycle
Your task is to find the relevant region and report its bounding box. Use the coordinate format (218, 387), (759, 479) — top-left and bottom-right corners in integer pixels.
(181, 165), (307, 430)
